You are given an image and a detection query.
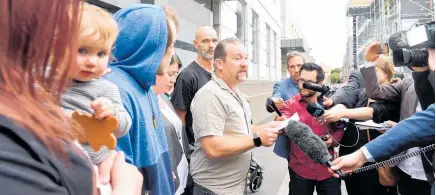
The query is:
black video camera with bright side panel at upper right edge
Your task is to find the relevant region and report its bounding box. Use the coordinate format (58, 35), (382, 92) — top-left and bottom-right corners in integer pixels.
(389, 21), (435, 67)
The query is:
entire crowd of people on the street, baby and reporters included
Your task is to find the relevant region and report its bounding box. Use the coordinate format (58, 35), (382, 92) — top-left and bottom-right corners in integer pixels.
(0, 0), (435, 195)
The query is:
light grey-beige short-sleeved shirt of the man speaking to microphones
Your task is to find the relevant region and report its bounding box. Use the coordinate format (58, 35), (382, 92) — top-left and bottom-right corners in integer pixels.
(190, 74), (252, 195)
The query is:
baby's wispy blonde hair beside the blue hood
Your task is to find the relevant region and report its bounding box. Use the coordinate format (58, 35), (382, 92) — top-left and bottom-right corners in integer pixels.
(79, 3), (118, 47)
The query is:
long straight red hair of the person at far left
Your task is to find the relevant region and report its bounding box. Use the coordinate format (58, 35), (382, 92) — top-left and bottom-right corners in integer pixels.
(0, 0), (80, 154)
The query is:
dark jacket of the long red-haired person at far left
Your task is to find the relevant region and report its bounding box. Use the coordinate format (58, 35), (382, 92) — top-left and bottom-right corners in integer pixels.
(0, 115), (93, 195)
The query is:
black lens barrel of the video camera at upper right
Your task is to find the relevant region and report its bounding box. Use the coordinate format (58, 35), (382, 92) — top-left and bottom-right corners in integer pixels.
(393, 49), (428, 67)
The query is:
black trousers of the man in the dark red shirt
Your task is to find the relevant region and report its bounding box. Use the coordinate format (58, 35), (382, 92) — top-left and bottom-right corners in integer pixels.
(291, 171), (341, 195)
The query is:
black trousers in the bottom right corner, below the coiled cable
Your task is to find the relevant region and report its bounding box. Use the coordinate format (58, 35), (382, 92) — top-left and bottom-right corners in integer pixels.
(398, 169), (431, 195)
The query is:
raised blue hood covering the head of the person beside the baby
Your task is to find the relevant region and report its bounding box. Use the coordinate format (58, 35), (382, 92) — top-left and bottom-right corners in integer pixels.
(110, 4), (168, 90)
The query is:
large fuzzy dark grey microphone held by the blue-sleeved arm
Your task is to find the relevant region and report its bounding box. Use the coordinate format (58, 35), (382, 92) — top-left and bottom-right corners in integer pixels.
(285, 120), (343, 178)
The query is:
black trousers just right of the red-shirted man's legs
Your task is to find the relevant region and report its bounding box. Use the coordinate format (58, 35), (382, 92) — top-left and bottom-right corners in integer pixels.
(345, 166), (398, 195)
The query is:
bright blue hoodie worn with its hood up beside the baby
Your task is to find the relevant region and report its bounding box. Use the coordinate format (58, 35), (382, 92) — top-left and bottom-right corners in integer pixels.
(105, 4), (174, 195)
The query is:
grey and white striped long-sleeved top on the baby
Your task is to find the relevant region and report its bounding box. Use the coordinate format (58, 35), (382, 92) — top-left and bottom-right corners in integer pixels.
(61, 78), (132, 165)
